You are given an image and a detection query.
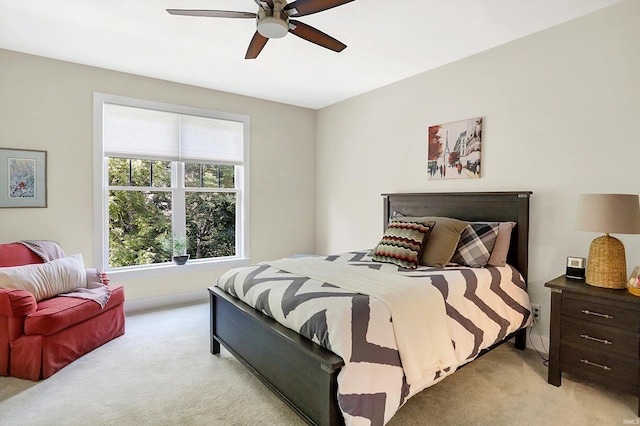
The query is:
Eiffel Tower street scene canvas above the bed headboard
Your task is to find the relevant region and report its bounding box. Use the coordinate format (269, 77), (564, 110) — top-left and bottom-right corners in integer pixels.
(427, 117), (483, 180)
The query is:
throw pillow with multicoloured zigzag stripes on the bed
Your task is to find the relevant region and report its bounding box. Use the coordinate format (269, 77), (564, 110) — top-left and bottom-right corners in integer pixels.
(372, 220), (435, 269)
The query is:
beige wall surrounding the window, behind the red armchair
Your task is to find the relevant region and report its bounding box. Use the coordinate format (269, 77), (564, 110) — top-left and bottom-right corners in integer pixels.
(0, 50), (316, 300)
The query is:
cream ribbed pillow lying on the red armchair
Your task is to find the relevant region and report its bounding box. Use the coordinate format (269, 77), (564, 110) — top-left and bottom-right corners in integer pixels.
(0, 254), (87, 302)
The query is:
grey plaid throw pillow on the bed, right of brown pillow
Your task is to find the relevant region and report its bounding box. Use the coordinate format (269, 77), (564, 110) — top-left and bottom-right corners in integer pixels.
(451, 222), (500, 268)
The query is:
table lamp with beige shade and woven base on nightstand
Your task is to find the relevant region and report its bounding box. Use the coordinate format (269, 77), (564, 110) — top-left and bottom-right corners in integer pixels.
(575, 194), (640, 288)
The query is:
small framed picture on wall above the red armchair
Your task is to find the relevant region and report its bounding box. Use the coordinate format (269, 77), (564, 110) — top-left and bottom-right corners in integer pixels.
(0, 148), (47, 208)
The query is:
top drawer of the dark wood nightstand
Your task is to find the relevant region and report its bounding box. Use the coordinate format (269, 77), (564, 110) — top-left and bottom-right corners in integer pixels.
(562, 295), (640, 332)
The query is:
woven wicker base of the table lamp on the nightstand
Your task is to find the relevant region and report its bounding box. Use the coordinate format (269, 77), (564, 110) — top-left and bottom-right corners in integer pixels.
(585, 234), (627, 288)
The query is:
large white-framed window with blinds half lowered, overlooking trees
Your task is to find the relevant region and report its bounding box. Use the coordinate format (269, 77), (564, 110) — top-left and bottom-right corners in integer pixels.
(94, 93), (249, 278)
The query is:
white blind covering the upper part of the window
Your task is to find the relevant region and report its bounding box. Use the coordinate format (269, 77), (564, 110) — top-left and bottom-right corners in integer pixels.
(103, 103), (243, 165)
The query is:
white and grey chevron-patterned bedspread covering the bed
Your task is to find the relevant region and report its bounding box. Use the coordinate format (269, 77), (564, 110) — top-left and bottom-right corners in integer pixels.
(215, 251), (531, 426)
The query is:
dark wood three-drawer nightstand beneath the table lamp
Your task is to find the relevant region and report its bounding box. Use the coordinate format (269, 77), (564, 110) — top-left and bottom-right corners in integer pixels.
(545, 275), (640, 415)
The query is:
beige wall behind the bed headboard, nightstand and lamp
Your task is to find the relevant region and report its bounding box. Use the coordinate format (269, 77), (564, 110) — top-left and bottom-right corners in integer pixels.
(316, 0), (640, 342)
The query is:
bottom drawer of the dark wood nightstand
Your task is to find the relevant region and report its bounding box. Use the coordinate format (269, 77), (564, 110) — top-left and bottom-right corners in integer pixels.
(560, 343), (638, 386)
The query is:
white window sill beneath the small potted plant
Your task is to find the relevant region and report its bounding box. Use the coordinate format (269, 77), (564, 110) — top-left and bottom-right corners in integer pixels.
(106, 258), (251, 281)
